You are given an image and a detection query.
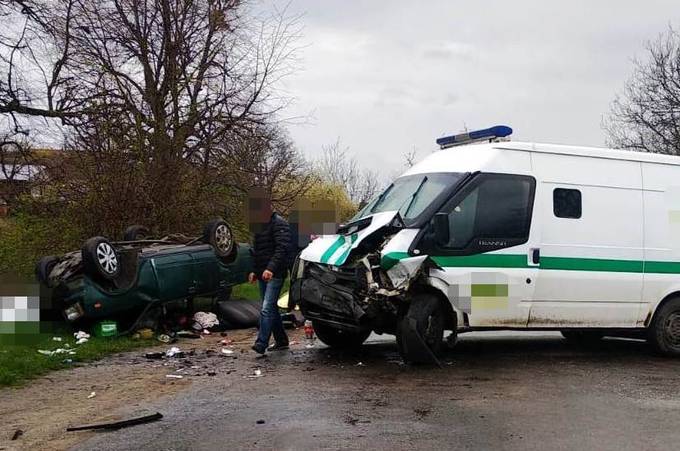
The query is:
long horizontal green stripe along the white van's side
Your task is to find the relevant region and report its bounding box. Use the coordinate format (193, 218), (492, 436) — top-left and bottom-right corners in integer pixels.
(382, 252), (680, 274)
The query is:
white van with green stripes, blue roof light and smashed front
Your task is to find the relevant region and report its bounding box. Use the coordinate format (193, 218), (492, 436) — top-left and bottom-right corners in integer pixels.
(291, 126), (680, 362)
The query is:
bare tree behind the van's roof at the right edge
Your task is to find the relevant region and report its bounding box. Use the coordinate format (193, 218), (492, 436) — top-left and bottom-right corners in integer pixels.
(603, 28), (680, 155)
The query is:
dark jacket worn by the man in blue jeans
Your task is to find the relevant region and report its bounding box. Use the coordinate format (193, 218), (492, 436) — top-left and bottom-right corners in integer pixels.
(253, 213), (291, 279)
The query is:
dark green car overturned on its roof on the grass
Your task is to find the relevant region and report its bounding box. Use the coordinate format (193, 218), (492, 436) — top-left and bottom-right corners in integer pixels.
(36, 219), (252, 322)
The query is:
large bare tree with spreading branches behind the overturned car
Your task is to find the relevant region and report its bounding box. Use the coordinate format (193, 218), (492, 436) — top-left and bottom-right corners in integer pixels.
(0, 0), (299, 231)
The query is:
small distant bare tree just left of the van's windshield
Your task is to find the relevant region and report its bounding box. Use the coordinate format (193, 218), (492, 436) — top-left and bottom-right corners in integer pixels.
(316, 138), (380, 206)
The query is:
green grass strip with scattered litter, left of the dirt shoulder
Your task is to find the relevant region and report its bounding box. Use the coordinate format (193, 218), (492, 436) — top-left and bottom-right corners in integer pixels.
(0, 323), (157, 386)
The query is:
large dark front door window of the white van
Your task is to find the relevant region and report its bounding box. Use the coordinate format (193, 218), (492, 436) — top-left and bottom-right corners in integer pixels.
(436, 174), (536, 254)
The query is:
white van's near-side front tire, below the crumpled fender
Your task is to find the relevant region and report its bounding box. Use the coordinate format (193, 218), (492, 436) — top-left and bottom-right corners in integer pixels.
(397, 293), (446, 363)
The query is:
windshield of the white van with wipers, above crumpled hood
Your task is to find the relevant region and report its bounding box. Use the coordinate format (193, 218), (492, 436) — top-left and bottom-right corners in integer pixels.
(350, 173), (462, 224)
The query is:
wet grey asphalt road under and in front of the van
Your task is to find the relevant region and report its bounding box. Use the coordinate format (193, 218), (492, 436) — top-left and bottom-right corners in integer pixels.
(76, 333), (680, 450)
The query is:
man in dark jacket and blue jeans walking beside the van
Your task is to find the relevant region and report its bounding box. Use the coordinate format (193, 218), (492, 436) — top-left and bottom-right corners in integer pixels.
(248, 191), (291, 354)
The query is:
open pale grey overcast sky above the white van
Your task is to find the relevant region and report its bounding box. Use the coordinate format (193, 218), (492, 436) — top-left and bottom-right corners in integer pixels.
(273, 0), (680, 174)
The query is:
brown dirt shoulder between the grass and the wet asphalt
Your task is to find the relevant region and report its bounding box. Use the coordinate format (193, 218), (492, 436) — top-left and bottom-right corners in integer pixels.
(0, 330), (266, 450)
